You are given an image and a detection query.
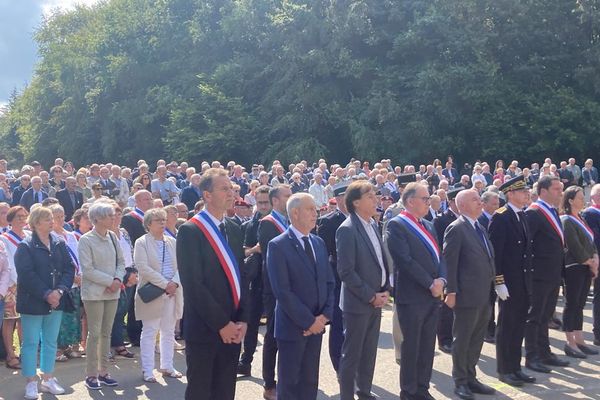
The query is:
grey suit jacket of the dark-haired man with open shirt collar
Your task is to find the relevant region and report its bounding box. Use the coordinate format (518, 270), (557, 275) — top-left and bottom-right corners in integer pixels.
(335, 214), (390, 314)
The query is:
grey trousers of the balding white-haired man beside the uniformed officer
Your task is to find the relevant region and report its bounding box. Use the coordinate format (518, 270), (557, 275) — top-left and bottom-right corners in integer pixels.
(452, 304), (490, 385)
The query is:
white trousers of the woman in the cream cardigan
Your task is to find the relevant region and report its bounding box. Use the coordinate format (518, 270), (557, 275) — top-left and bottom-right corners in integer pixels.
(140, 296), (177, 376)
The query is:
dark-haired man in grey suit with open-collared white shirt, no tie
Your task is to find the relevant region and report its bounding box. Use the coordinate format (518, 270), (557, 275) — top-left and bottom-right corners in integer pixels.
(335, 181), (390, 400)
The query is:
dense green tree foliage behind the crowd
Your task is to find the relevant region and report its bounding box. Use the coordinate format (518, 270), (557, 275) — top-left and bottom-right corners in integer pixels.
(0, 0), (600, 164)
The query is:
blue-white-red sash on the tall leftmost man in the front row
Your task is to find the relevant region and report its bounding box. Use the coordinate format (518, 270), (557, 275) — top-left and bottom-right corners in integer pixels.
(190, 211), (241, 308)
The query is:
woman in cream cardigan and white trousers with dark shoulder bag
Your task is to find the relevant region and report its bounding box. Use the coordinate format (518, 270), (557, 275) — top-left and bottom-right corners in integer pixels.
(133, 208), (183, 382)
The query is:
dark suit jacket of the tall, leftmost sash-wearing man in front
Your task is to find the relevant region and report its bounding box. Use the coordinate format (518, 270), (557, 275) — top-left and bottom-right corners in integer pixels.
(176, 218), (249, 343)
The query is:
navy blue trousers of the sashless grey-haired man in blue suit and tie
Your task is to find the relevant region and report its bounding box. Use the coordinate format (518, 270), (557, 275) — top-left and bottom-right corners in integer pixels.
(277, 335), (323, 400)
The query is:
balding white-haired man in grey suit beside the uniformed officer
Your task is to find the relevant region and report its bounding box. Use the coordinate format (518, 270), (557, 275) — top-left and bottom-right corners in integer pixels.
(443, 189), (495, 400)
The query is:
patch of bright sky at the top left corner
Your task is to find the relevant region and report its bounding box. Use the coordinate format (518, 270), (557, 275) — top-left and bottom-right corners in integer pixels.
(0, 0), (98, 106)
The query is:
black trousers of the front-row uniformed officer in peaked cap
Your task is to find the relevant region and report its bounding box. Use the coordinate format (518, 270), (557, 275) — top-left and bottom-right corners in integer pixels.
(496, 282), (529, 374)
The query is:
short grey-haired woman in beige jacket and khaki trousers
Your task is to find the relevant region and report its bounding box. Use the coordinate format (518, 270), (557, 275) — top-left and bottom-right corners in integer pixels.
(79, 200), (125, 390)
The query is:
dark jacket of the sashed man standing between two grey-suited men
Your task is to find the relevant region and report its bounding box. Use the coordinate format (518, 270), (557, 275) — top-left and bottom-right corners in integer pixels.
(386, 217), (446, 304)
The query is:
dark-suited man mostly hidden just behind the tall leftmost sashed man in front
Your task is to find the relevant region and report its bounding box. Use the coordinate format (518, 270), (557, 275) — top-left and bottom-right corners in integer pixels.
(237, 186), (271, 376)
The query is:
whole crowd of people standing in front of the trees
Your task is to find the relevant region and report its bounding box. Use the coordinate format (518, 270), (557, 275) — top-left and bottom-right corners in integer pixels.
(0, 157), (600, 400)
